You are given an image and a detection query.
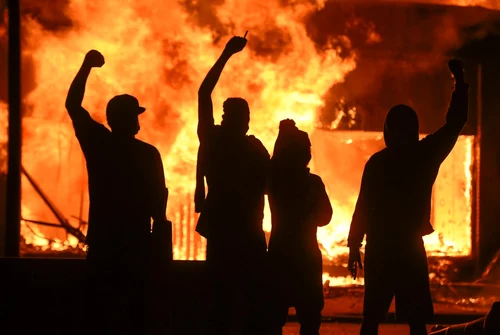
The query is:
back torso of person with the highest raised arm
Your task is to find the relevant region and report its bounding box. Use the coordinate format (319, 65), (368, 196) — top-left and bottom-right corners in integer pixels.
(200, 126), (269, 249)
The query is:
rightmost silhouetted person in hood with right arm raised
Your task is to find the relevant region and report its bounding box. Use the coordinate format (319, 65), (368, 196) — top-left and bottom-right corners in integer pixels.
(348, 60), (468, 335)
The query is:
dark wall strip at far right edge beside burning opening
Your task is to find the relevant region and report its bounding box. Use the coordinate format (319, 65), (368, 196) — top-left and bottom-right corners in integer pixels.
(458, 35), (500, 270)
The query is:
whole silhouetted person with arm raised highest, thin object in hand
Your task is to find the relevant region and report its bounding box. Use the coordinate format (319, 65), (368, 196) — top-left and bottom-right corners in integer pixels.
(195, 37), (269, 335)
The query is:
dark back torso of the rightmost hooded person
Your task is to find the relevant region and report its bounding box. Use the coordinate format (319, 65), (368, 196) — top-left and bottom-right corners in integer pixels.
(365, 140), (441, 244)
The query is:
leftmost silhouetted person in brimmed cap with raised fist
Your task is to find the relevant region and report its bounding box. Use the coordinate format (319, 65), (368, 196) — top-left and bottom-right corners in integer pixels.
(66, 50), (167, 334)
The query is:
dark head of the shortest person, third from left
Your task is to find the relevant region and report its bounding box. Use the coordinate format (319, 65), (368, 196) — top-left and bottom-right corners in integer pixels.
(271, 119), (311, 169)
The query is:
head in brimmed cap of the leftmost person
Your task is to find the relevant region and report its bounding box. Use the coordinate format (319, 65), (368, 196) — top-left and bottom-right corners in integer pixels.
(106, 94), (146, 136)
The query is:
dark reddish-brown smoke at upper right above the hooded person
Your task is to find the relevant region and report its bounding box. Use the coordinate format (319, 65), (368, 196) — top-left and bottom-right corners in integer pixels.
(308, 1), (500, 132)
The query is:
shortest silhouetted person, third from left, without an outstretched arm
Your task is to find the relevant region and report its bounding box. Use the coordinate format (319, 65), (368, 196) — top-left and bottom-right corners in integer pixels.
(268, 120), (332, 335)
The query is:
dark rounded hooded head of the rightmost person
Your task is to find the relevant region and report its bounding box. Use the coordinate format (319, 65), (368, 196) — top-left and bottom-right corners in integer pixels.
(384, 105), (418, 147)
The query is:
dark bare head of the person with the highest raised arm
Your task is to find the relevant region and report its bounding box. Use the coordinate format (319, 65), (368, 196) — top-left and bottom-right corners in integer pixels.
(221, 98), (250, 137)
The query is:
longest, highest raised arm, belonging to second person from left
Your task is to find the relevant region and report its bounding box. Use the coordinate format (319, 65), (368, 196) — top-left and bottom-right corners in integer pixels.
(198, 36), (247, 143)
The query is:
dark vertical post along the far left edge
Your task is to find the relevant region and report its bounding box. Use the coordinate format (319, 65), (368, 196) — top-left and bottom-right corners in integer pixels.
(5, 0), (22, 257)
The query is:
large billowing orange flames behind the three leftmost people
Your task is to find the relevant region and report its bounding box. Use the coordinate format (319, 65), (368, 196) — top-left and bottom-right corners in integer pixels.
(16, 0), (355, 259)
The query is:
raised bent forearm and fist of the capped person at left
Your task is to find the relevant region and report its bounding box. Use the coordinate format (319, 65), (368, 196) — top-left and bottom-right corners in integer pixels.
(66, 50), (104, 123)
